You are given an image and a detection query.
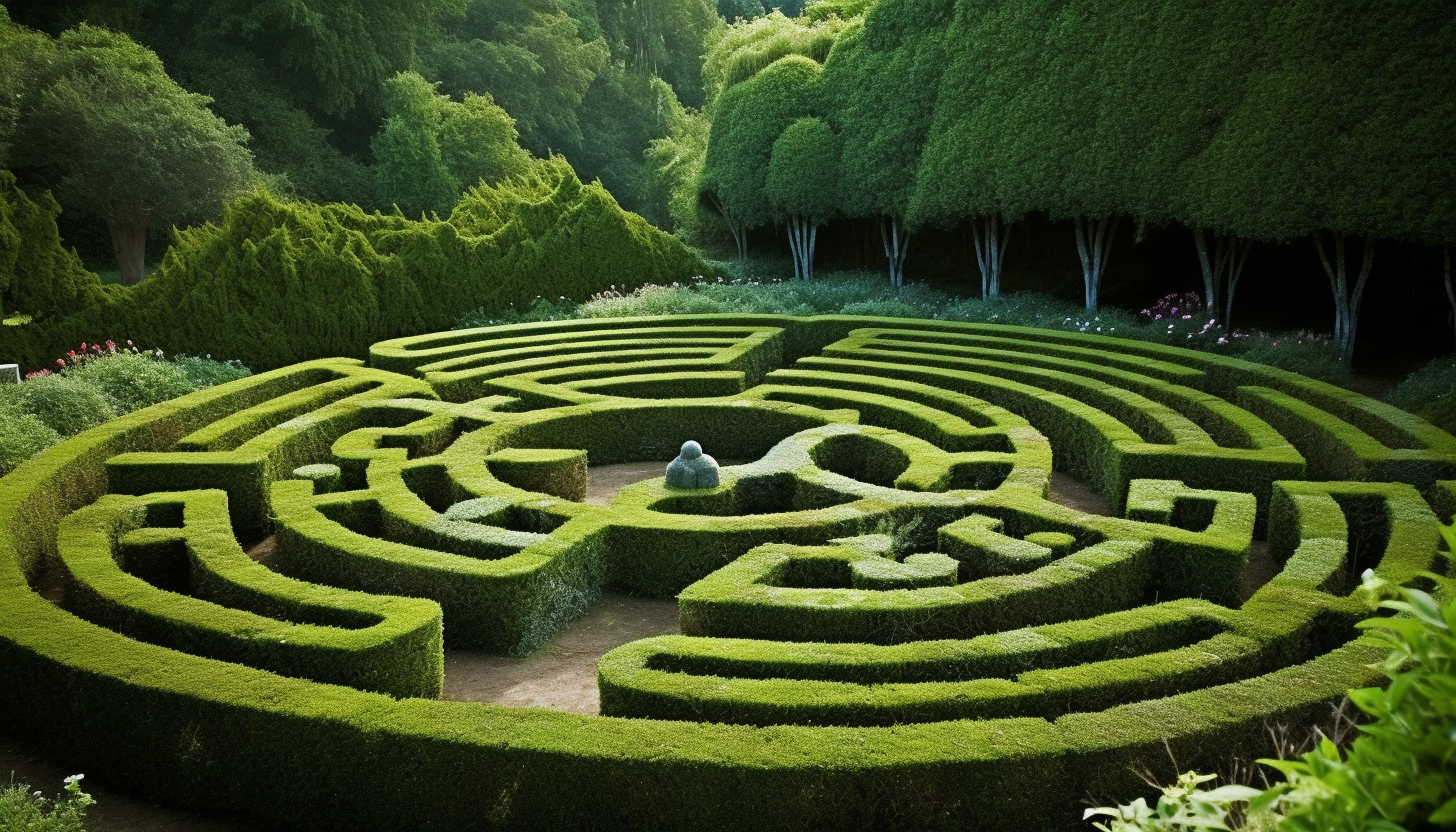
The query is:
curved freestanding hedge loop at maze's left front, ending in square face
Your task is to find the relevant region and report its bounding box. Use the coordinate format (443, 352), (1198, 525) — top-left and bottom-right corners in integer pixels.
(57, 491), (444, 696)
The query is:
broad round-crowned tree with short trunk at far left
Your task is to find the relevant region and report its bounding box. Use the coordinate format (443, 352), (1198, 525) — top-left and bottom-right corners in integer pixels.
(22, 25), (256, 284)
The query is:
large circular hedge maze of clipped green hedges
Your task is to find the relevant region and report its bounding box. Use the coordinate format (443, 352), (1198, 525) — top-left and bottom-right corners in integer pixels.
(0, 316), (1456, 829)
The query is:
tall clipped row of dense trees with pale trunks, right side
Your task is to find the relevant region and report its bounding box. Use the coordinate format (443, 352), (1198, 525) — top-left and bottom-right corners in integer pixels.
(693, 0), (1456, 358)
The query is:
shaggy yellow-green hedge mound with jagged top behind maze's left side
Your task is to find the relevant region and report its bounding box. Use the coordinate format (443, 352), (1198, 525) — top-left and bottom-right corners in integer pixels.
(0, 159), (705, 369)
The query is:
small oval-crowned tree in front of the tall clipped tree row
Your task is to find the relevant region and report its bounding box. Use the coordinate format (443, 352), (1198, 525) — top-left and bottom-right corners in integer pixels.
(767, 118), (840, 280)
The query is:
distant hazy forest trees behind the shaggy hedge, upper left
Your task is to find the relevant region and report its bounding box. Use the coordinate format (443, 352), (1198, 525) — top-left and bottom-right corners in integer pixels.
(0, 0), (728, 224)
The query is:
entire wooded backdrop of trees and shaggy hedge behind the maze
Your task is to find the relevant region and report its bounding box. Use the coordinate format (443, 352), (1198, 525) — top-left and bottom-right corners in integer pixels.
(0, 0), (1456, 381)
